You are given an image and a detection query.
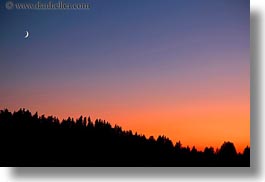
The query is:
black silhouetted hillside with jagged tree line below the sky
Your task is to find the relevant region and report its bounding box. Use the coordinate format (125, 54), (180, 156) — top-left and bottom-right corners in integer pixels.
(0, 109), (250, 166)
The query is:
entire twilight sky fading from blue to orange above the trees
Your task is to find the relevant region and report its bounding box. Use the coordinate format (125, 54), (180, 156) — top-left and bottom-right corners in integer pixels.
(0, 0), (250, 151)
